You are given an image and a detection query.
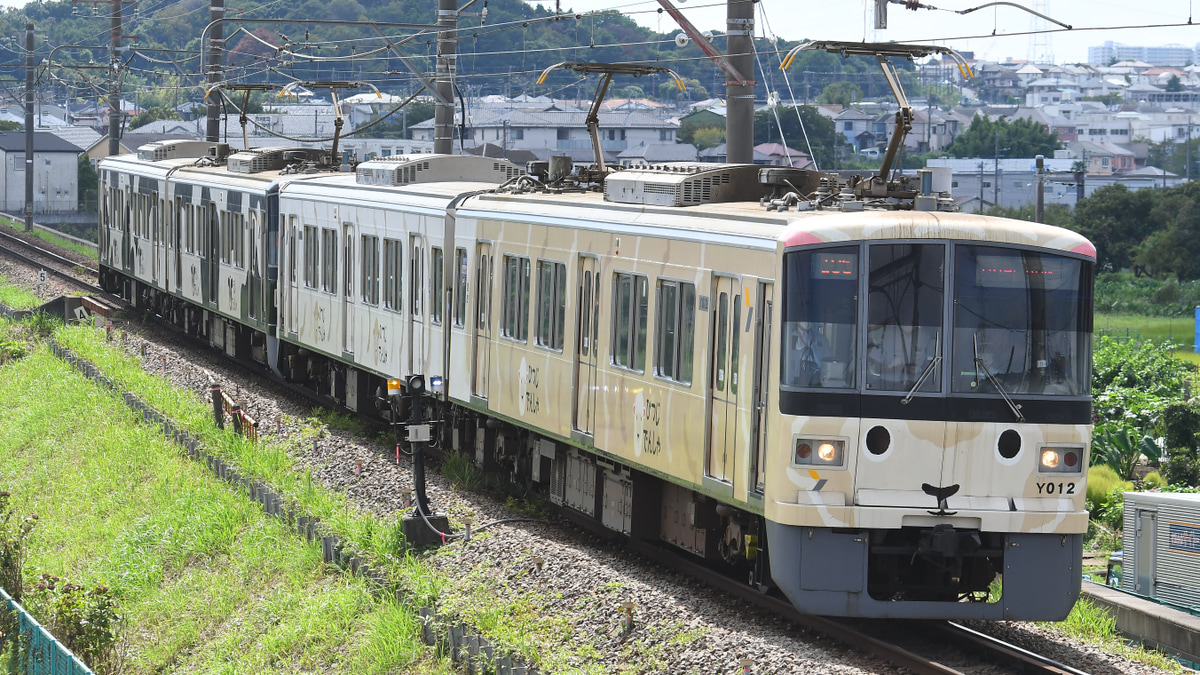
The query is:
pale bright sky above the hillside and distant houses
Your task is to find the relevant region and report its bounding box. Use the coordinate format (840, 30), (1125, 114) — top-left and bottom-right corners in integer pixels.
(535, 0), (1200, 64)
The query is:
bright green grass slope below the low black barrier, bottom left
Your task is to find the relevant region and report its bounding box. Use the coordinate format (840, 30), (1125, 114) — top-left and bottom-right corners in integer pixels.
(0, 348), (448, 674)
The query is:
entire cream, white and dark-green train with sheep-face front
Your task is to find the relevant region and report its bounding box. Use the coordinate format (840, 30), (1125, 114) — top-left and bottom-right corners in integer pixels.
(100, 144), (1094, 620)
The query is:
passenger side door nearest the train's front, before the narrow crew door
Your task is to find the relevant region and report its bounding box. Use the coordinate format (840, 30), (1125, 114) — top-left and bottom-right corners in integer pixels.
(704, 274), (742, 483)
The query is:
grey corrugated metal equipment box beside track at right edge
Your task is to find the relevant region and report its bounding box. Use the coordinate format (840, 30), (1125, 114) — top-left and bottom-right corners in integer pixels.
(1121, 492), (1200, 608)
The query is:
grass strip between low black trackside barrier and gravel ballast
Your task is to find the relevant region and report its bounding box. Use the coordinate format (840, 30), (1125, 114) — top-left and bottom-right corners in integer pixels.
(44, 327), (676, 674)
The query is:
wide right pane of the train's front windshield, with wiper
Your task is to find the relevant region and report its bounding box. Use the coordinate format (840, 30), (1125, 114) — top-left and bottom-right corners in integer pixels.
(950, 246), (1092, 396)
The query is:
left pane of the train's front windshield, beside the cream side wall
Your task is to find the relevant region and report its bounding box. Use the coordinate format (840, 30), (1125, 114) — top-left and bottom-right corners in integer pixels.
(780, 246), (858, 389)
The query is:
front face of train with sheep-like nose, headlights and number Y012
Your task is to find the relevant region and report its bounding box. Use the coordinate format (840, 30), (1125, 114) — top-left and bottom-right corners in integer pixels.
(764, 211), (1094, 620)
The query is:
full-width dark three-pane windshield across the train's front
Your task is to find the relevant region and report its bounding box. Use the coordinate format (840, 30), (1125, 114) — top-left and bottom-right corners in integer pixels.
(780, 241), (1092, 402)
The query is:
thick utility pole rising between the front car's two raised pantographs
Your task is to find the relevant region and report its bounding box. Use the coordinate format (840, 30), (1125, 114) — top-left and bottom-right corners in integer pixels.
(725, 0), (748, 165)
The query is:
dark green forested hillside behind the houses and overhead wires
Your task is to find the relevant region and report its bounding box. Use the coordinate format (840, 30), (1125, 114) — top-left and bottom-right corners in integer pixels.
(0, 0), (912, 104)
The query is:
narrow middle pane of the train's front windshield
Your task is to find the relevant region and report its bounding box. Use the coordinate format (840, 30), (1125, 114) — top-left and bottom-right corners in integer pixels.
(864, 244), (946, 393)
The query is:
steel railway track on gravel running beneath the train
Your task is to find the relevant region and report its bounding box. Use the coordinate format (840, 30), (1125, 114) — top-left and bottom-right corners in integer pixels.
(0, 243), (1086, 675)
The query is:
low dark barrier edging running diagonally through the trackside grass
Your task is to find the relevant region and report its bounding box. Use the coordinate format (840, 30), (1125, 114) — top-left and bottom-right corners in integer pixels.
(48, 339), (538, 675)
